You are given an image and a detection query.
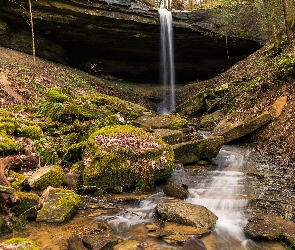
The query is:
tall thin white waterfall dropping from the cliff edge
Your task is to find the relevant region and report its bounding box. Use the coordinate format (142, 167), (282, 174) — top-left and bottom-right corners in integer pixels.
(158, 9), (175, 114)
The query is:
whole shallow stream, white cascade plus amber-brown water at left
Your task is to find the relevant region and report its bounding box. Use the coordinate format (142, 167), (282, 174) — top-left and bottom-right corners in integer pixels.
(0, 145), (284, 250)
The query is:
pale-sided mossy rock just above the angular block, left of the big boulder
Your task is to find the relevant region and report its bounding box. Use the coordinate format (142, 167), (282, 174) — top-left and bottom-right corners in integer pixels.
(28, 165), (64, 190)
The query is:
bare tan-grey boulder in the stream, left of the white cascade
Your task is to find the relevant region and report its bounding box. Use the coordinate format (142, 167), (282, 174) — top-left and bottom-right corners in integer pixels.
(156, 202), (218, 229)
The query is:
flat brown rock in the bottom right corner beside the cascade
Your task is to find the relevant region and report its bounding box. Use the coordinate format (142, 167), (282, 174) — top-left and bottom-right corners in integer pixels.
(244, 214), (295, 249)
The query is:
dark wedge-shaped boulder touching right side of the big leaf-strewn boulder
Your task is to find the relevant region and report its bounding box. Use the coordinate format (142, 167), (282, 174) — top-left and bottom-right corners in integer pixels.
(172, 136), (223, 163)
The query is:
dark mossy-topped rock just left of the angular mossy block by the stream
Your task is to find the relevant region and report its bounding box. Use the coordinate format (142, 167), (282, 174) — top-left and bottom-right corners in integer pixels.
(10, 192), (39, 219)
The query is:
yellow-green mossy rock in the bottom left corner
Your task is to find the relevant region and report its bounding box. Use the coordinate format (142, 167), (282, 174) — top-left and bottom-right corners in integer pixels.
(0, 238), (41, 250)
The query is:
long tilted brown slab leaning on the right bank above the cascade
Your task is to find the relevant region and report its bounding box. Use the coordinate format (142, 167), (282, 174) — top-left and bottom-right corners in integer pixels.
(212, 111), (273, 143)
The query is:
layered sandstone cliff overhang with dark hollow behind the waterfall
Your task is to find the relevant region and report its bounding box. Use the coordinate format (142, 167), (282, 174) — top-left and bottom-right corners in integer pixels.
(0, 0), (260, 83)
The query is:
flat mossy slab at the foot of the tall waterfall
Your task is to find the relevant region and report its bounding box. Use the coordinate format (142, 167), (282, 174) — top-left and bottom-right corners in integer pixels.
(134, 114), (187, 129)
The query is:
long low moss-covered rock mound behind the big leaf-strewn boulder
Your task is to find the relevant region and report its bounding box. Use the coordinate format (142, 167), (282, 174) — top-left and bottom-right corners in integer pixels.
(40, 89), (146, 126)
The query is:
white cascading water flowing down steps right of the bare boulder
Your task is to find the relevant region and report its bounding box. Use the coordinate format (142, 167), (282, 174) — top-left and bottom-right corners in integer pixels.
(187, 146), (260, 250)
